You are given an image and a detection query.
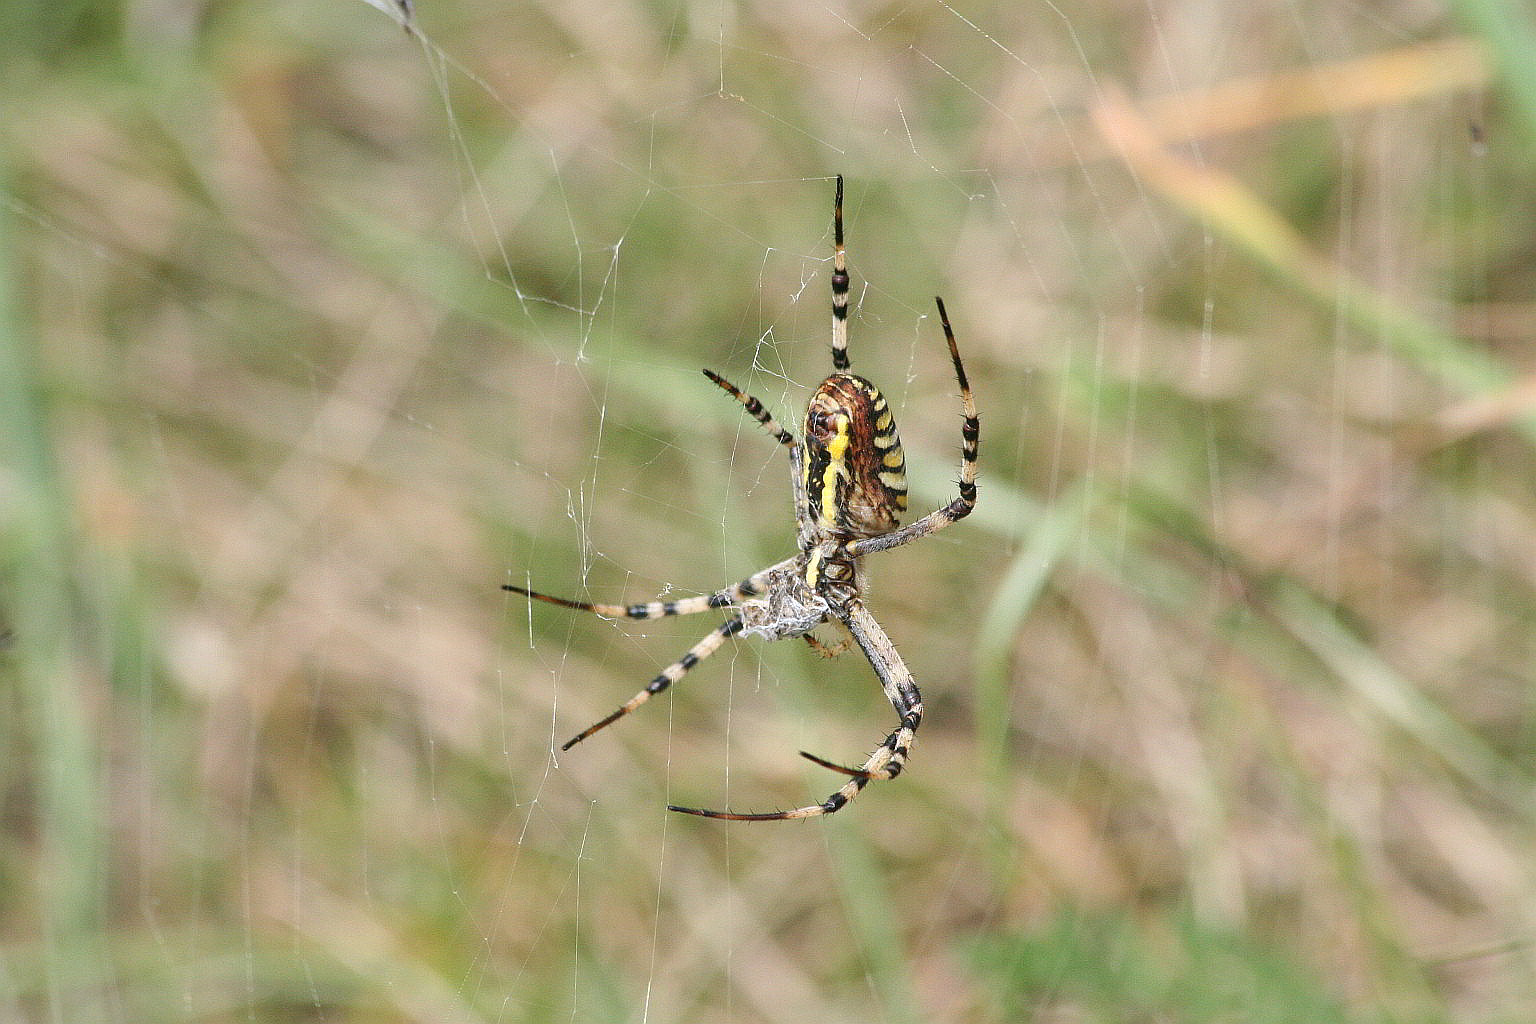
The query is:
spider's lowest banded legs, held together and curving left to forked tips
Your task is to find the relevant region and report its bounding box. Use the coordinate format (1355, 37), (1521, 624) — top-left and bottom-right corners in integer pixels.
(668, 597), (923, 821)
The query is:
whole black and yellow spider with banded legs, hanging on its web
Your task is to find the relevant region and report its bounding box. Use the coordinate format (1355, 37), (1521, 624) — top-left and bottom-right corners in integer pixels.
(504, 175), (982, 821)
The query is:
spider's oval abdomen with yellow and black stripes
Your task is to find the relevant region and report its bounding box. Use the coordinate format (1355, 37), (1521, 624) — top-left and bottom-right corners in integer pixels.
(803, 373), (906, 537)
